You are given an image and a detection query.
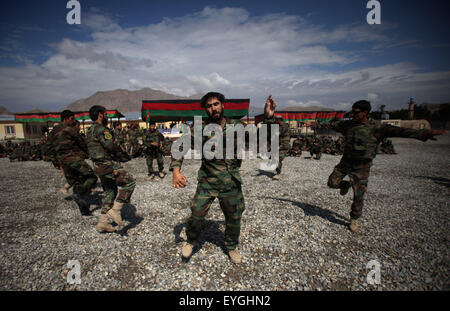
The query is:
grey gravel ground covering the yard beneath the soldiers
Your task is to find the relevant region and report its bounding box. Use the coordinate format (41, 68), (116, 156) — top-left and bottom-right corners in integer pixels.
(0, 134), (450, 291)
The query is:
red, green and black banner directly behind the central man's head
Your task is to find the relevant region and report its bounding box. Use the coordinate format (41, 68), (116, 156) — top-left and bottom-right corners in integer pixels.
(141, 99), (250, 122)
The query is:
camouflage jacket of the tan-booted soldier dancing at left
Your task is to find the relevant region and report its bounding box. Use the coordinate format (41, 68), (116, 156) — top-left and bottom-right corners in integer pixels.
(86, 123), (129, 162)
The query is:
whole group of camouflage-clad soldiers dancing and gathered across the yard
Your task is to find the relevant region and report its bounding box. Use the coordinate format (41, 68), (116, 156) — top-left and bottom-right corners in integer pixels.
(2, 92), (445, 263)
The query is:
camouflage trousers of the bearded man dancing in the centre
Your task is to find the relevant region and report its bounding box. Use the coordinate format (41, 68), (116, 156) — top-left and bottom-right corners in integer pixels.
(186, 183), (245, 251)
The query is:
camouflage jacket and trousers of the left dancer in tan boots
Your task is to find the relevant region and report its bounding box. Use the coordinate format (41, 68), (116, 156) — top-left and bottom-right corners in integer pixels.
(86, 123), (136, 214)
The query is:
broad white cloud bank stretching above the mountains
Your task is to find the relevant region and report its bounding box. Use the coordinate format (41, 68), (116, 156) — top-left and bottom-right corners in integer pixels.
(0, 7), (450, 109)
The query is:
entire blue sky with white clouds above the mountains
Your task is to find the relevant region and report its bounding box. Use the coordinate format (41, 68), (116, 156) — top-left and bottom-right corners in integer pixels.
(0, 0), (450, 112)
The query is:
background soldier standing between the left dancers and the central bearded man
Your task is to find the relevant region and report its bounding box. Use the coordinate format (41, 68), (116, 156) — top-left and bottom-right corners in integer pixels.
(144, 122), (164, 180)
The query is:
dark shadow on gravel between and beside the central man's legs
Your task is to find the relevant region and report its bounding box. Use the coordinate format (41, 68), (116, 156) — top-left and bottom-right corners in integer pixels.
(173, 220), (228, 263)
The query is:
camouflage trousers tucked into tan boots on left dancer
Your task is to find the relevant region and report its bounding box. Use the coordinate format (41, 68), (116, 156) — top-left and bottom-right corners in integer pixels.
(94, 162), (136, 214)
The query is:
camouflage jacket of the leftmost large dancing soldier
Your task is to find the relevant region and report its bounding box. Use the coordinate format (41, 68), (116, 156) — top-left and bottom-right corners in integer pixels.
(51, 125), (88, 165)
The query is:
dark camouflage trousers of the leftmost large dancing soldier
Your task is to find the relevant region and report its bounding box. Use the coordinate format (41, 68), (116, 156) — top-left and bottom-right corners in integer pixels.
(62, 160), (97, 194)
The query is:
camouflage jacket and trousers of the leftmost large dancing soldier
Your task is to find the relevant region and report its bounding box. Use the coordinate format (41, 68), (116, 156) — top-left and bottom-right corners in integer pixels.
(49, 125), (97, 195)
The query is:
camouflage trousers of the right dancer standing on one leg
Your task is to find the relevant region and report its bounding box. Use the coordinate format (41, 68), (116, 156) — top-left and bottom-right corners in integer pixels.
(328, 159), (372, 219)
